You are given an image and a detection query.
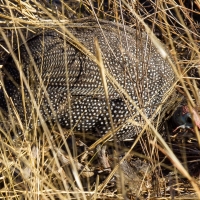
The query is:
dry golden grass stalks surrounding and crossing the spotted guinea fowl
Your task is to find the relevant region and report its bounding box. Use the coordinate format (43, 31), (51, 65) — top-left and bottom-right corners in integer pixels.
(0, 0), (200, 199)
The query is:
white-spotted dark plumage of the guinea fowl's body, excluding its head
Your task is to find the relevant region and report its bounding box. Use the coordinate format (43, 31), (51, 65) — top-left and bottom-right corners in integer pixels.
(0, 20), (176, 140)
